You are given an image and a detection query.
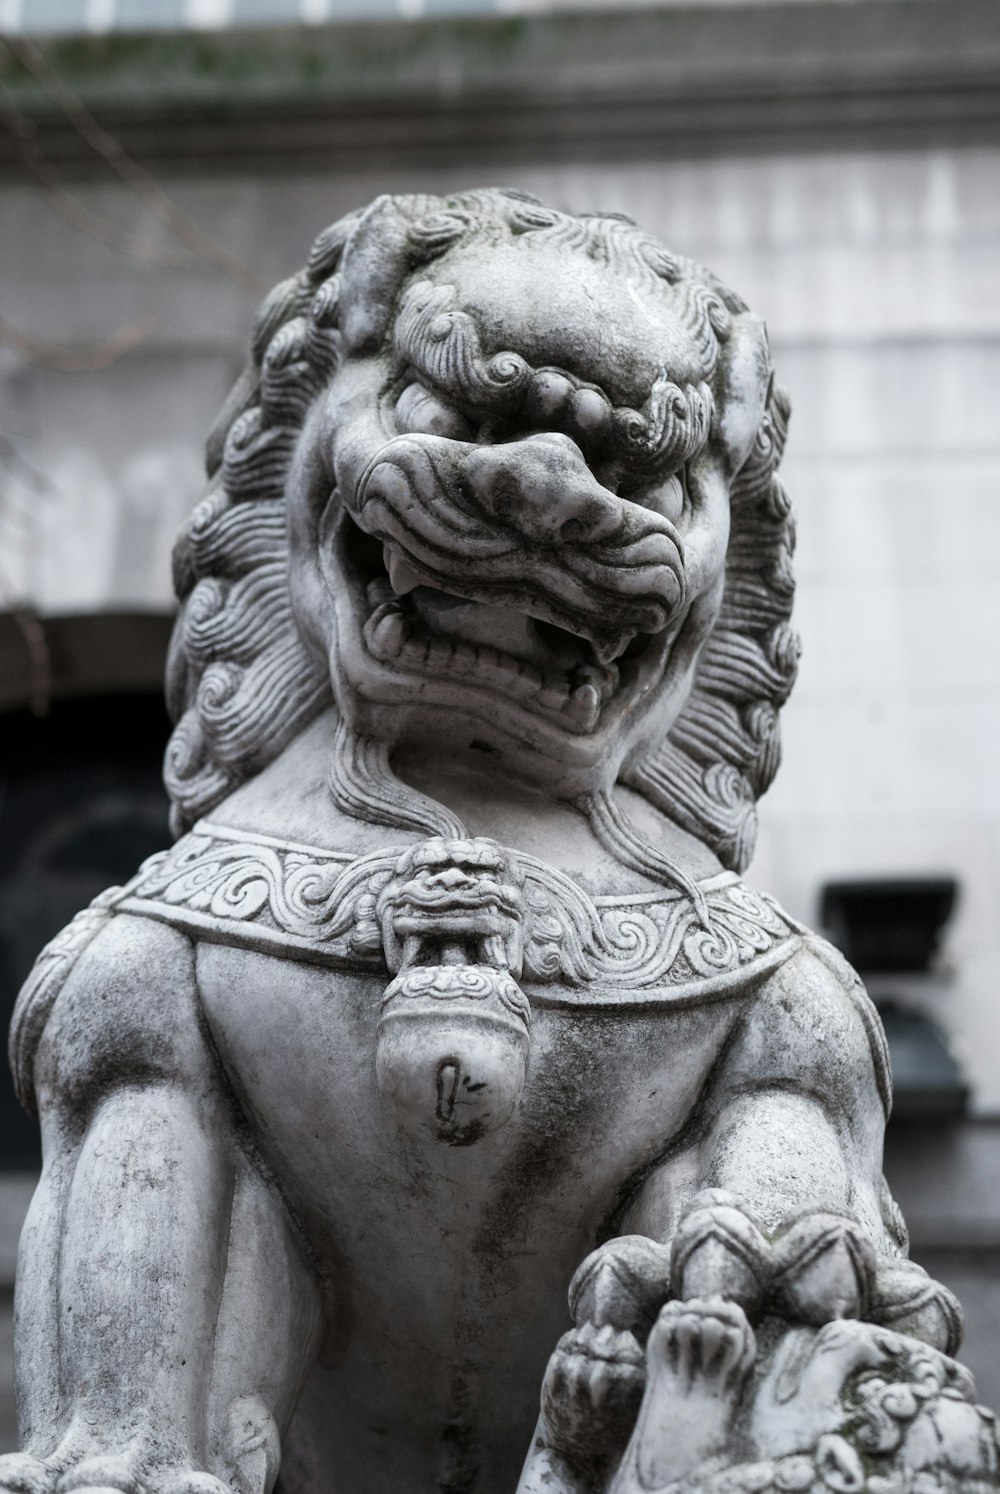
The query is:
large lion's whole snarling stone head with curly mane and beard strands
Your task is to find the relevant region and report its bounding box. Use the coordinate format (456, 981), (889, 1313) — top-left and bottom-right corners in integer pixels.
(166, 190), (798, 870)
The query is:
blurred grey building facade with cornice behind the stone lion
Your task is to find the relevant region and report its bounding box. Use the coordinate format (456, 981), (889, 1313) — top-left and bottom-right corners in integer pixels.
(0, 0), (1000, 1434)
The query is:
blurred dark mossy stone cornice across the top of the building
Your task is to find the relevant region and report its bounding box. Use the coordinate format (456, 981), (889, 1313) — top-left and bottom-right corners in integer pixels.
(0, 0), (1000, 175)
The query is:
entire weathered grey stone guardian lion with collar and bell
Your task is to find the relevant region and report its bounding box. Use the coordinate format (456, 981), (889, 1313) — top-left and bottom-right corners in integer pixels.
(0, 191), (997, 1494)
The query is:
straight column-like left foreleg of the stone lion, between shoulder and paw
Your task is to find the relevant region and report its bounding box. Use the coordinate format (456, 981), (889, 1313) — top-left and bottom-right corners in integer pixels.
(43, 1083), (235, 1482)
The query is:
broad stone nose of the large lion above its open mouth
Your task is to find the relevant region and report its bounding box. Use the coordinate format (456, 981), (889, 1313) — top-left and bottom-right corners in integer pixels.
(463, 433), (622, 545)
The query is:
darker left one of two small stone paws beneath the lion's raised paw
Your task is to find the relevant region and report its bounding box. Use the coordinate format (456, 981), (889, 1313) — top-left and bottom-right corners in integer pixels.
(541, 1324), (644, 1464)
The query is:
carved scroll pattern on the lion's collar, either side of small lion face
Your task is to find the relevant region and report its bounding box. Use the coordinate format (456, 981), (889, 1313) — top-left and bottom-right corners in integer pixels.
(120, 823), (797, 999)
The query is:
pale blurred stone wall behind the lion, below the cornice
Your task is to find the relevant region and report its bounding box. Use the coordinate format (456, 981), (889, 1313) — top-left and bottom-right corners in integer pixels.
(0, 149), (1000, 1110)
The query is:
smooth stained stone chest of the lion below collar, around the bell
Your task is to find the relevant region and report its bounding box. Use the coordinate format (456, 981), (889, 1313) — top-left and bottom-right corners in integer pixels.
(189, 920), (771, 1494)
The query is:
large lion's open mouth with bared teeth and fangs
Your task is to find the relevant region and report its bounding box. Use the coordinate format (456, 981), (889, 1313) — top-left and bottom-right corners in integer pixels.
(336, 511), (664, 734)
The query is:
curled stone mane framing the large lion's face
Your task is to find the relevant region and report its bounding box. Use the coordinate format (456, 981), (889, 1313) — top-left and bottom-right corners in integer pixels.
(164, 191), (798, 871)
